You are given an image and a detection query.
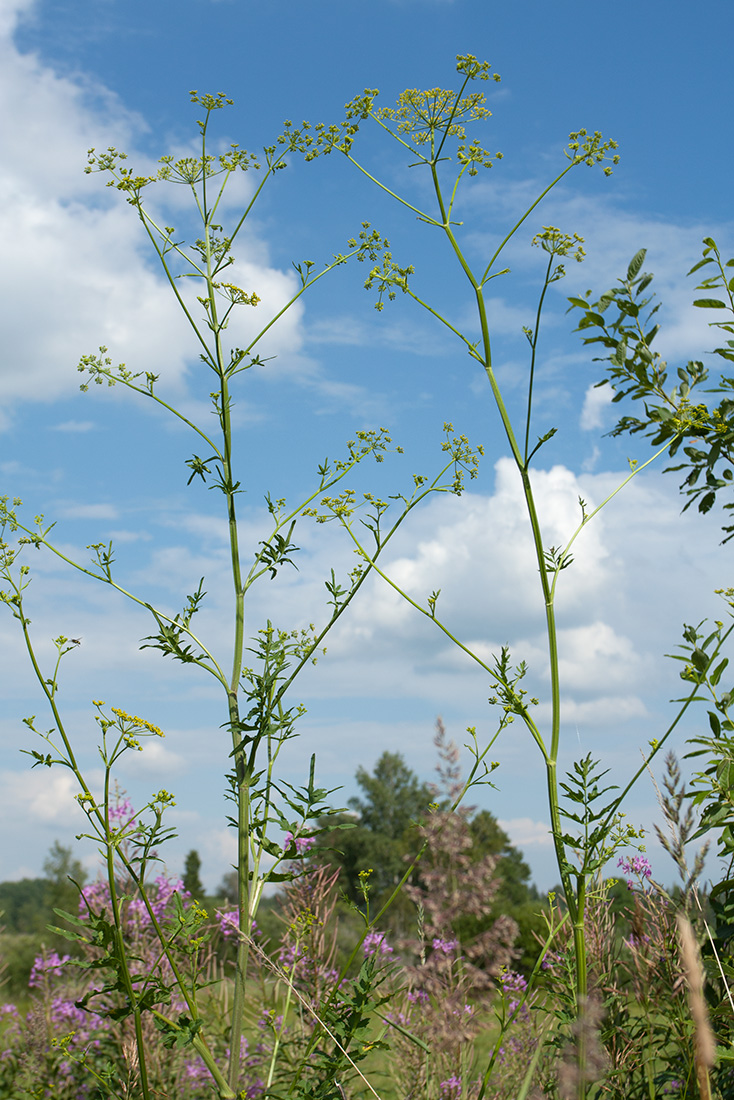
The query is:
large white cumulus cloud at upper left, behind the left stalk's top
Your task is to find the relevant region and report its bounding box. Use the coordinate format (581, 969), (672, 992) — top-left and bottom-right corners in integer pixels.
(0, 0), (320, 432)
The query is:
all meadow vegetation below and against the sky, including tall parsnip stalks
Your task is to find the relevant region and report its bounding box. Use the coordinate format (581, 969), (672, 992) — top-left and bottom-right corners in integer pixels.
(0, 55), (734, 1100)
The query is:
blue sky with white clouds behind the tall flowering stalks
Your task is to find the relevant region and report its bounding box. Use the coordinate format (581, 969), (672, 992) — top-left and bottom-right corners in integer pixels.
(0, 0), (733, 888)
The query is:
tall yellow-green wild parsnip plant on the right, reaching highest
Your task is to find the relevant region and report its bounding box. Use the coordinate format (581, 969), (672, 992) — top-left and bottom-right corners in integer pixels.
(294, 55), (731, 1082)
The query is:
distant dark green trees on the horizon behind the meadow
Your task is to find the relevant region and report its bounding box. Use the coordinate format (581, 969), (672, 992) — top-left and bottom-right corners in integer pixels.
(0, 739), (543, 987)
